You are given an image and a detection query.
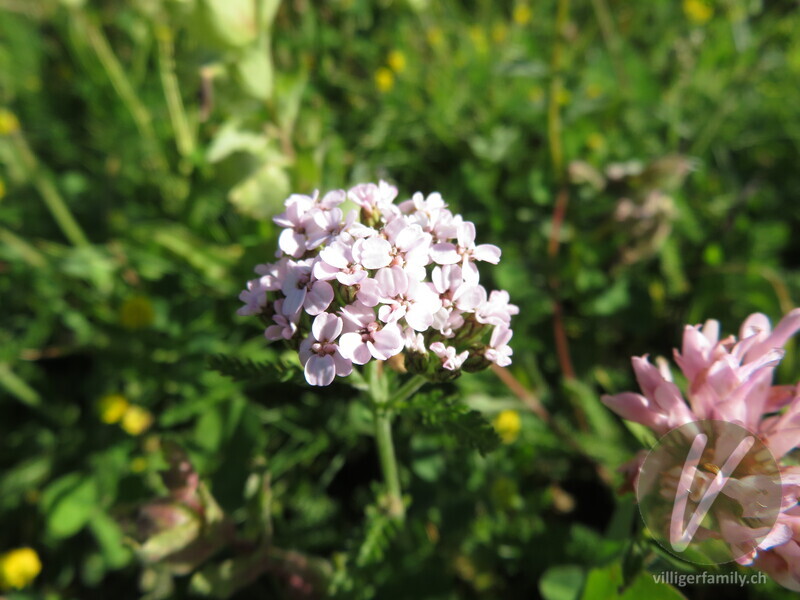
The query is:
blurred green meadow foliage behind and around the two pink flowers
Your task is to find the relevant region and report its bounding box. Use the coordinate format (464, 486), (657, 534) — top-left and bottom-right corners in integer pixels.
(0, 0), (800, 600)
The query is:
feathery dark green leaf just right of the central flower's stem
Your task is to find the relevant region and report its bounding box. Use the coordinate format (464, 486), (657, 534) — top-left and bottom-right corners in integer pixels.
(399, 390), (500, 455)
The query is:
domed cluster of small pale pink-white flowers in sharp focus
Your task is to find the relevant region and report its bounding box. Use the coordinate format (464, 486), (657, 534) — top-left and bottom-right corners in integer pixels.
(238, 181), (519, 385)
